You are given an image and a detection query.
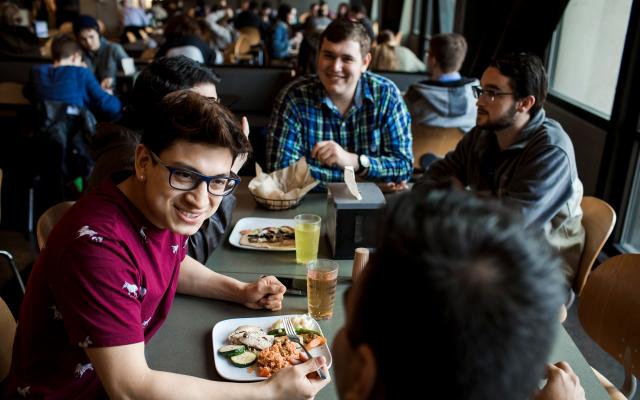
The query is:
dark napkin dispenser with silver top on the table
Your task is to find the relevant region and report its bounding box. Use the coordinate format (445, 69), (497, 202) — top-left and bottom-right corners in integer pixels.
(326, 182), (386, 259)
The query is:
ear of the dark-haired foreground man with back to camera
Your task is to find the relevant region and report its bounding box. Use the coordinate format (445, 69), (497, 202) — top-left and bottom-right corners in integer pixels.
(344, 344), (378, 400)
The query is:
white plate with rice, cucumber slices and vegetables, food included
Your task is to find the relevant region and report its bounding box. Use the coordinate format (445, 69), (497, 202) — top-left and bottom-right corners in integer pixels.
(211, 315), (332, 382)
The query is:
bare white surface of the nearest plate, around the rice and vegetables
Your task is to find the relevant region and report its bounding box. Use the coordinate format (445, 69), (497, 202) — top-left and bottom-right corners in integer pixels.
(211, 315), (332, 382)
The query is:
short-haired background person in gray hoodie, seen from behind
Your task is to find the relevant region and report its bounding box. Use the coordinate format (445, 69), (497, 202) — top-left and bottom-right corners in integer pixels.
(405, 33), (478, 133)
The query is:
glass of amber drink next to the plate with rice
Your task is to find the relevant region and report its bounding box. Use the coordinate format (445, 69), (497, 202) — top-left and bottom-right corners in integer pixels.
(307, 258), (338, 319)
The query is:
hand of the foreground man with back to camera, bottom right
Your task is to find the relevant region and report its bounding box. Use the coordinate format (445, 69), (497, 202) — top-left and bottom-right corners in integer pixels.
(534, 361), (586, 400)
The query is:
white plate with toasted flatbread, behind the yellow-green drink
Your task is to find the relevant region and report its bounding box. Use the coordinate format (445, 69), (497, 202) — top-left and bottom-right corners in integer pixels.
(229, 217), (296, 251)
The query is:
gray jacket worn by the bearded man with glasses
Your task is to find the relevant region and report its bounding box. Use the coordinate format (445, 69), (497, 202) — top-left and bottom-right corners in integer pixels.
(414, 110), (585, 280)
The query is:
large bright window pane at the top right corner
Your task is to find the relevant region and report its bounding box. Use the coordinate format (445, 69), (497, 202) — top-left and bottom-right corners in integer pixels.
(550, 0), (633, 119)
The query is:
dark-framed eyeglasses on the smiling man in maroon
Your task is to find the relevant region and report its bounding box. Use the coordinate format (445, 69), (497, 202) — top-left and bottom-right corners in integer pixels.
(149, 151), (240, 196)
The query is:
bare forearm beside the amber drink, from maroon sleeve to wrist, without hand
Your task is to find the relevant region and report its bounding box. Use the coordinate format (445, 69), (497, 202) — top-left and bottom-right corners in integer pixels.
(178, 256), (246, 302)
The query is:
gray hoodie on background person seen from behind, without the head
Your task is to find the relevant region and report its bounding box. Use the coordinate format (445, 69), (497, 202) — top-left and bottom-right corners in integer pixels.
(404, 78), (480, 132)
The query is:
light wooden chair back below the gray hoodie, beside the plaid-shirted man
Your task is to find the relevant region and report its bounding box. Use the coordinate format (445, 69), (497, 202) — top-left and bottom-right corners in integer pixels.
(411, 124), (464, 170)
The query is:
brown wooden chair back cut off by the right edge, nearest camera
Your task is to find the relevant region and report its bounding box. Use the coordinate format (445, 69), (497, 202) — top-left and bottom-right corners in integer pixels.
(578, 254), (640, 399)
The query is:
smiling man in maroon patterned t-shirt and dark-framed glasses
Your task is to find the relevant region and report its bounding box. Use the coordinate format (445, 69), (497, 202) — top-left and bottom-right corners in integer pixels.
(6, 90), (329, 400)
